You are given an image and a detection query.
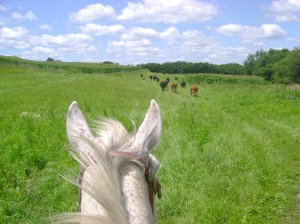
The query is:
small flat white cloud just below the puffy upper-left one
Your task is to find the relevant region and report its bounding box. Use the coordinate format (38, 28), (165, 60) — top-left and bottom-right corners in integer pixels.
(80, 23), (126, 36)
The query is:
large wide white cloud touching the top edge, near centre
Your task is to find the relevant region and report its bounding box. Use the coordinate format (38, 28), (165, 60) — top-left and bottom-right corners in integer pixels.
(117, 0), (218, 24)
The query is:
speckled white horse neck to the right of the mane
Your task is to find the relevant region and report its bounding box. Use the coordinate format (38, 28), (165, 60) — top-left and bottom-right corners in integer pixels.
(120, 163), (156, 224)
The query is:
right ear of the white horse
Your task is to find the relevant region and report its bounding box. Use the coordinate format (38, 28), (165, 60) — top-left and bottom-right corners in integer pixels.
(134, 100), (162, 151)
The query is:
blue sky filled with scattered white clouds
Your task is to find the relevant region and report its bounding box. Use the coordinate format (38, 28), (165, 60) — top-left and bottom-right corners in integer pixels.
(0, 0), (300, 64)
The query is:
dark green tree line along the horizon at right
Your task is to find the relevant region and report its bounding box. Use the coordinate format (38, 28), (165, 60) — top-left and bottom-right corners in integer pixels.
(139, 47), (300, 84)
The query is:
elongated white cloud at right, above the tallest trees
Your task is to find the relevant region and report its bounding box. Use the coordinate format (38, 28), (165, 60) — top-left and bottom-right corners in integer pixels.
(217, 24), (287, 42)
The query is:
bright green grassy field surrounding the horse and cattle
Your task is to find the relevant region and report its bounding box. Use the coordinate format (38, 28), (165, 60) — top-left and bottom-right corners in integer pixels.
(0, 58), (300, 224)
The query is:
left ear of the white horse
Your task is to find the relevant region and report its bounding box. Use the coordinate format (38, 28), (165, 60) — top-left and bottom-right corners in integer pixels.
(67, 101), (94, 155)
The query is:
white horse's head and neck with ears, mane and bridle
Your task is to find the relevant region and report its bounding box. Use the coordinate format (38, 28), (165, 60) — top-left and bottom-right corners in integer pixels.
(55, 100), (162, 224)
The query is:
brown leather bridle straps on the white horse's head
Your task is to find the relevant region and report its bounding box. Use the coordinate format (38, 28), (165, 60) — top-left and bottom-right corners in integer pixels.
(77, 151), (162, 213)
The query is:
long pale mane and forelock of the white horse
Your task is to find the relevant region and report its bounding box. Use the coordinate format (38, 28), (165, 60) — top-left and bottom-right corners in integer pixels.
(52, 119), (140, 224)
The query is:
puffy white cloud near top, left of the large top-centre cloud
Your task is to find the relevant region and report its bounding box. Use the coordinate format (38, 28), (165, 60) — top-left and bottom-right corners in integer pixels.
(69, 4), (115, 23)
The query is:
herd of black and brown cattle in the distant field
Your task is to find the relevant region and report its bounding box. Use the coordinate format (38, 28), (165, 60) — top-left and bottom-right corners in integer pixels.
(141, 74), (198, 96)
